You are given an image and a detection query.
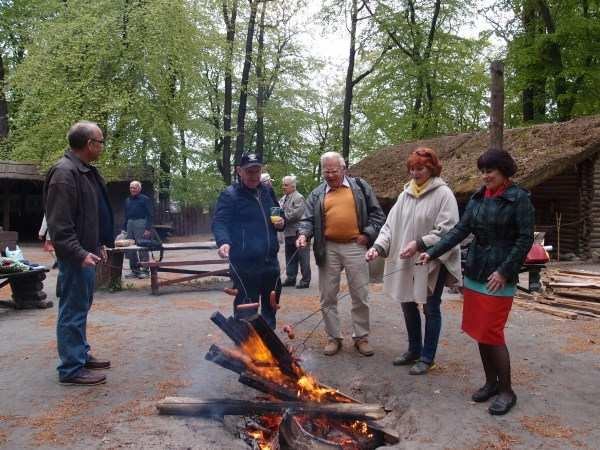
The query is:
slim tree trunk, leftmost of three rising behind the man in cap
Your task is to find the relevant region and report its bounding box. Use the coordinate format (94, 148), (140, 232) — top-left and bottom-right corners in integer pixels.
(217, 0), (238, 185)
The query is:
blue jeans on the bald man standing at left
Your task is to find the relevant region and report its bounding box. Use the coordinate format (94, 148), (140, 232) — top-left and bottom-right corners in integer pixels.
(56, 261), (96, 381)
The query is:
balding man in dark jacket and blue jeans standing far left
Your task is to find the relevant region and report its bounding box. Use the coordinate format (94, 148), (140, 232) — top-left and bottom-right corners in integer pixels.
(44, 121), (114, 386)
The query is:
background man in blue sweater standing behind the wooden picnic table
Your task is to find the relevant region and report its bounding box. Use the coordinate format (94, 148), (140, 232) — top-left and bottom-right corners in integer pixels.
(123, 180), (154, 278)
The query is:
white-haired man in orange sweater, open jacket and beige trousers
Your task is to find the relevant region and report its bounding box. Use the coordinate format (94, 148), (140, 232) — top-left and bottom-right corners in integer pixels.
(296, 152), (385, 356)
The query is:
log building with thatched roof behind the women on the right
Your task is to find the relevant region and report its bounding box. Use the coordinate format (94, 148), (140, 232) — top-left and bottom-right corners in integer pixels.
(350, 116), (600, 257)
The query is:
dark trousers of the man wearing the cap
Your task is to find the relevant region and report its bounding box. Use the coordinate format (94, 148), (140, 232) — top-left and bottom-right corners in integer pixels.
(231, 260), (281, 330)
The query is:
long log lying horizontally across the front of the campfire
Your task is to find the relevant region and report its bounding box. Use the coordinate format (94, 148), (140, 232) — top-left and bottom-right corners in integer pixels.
(156, 397), (385, 420)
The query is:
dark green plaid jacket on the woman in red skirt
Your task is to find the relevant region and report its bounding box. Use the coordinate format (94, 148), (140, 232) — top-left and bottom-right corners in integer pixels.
(427, 185), (535, 283)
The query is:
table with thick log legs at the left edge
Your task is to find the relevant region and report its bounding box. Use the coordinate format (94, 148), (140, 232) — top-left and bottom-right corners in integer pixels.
(0, 266), (53, 309)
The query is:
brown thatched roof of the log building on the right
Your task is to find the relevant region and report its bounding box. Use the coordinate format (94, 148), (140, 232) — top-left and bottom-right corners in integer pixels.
(350, 116), (600, 203)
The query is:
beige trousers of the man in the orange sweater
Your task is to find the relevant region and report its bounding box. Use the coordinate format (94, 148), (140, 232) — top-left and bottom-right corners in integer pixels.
(319, 241), (370, 339)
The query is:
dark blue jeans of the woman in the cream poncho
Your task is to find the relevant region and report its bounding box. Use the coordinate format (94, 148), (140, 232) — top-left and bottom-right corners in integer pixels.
(402, 265), (448, 364)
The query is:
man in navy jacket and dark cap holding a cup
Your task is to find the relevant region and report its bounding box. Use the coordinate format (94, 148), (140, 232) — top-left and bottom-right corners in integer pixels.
(212, 153), (285, 329)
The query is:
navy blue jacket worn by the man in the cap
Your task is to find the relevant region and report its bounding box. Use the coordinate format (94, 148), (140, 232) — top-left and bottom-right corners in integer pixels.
(212, 183), (283, 265)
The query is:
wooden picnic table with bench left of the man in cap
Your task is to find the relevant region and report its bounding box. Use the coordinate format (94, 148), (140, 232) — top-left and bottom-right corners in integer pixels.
(108, 241), (229, 295)
